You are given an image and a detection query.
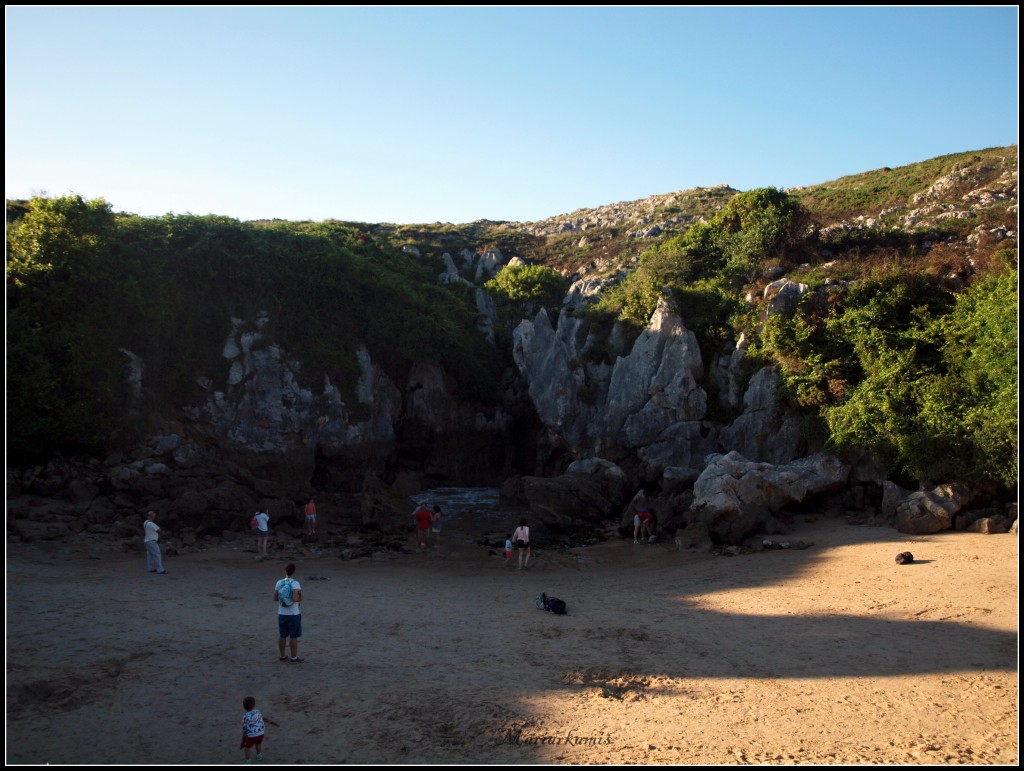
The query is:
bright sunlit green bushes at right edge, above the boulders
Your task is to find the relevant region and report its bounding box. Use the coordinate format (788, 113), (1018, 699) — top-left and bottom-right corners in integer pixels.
(761, 251), (1018, 486)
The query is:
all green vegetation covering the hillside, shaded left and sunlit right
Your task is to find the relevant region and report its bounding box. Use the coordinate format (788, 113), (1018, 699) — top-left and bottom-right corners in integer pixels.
(7, 146), (1018, 486)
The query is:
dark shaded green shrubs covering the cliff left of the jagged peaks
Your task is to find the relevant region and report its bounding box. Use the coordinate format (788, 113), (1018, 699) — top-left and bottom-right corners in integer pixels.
(7, 197), (499, 462)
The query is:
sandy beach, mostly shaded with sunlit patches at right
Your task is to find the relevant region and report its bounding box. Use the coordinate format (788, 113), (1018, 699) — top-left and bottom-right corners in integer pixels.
(6, 517), (1019, 765)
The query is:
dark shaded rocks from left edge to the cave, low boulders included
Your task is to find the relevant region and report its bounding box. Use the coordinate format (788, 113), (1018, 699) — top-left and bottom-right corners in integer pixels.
(2, 301), (531, 539)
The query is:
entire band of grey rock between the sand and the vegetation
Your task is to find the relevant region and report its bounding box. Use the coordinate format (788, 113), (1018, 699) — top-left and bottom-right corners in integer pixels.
(7, 296), (1017, 550)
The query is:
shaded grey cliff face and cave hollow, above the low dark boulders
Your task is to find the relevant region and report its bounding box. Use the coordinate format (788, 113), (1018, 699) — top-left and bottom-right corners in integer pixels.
(187, 313), (520, 491)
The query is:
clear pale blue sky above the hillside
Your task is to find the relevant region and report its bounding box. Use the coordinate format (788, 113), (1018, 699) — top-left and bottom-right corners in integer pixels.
(5, 5), (1019, 223)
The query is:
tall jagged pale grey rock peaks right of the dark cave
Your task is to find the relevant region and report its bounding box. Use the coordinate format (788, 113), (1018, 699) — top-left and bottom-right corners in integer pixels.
(513, 300), (811, 481)
